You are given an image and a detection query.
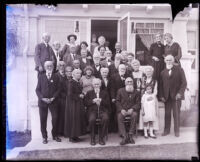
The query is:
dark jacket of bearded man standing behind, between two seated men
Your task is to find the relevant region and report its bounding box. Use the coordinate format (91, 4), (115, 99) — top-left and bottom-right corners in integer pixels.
(110, 73), (127, 99)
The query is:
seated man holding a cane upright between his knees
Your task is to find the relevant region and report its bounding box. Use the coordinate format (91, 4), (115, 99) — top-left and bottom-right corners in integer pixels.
(85, 78), (110, 145)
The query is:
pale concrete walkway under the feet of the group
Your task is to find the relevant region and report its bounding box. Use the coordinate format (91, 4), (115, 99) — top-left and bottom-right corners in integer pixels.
(6, 127), (198, 160)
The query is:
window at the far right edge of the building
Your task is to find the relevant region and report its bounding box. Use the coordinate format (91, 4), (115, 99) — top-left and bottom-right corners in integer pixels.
(187, 31), (198, 70)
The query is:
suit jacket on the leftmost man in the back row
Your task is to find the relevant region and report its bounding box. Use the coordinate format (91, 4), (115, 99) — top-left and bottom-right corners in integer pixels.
(34, 43), (57, 71)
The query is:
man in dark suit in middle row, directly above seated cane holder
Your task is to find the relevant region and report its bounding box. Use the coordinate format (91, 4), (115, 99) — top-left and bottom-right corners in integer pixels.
(92, 53), (101, 78)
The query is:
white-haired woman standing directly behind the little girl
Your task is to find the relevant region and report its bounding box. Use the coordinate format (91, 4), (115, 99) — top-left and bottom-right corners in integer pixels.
(139, 66), (159, 130)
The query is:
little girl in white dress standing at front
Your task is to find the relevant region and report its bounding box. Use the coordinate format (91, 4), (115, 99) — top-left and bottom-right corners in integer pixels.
(141, 85), (158, 138)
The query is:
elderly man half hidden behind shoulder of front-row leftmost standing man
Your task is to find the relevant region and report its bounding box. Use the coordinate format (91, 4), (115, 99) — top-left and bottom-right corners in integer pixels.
(56, 61), (67, 136)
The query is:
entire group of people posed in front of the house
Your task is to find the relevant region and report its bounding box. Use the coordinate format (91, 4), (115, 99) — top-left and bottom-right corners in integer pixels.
(35, 33), (187, 145)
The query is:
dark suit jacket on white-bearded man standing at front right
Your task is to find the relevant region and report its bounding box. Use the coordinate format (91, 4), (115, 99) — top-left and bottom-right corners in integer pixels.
(160, 66), (187, 100)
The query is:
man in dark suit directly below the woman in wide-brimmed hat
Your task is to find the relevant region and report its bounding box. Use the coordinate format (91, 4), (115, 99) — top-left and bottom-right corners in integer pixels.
(63, 45), (81, 66)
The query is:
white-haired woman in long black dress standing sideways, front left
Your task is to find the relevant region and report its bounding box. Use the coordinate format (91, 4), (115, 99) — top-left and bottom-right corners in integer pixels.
(65, 69), (86, 142)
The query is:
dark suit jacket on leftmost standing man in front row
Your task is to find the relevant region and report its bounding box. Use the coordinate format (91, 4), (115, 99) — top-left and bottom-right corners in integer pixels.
(36, 73), (60, 106)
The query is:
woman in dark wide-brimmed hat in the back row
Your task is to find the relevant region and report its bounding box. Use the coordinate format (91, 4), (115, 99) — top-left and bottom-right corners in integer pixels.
(61, 34), (80, 56)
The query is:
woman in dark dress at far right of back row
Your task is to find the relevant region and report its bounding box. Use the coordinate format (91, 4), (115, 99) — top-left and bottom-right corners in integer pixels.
(164, 33), (182, 65)
